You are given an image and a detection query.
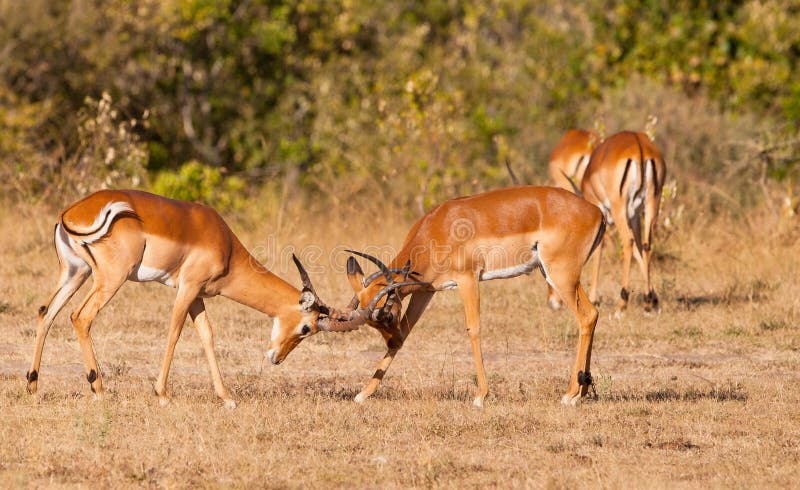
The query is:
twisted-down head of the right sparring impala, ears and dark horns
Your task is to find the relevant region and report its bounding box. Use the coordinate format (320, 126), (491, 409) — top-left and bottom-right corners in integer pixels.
(347, 250), (432, 327)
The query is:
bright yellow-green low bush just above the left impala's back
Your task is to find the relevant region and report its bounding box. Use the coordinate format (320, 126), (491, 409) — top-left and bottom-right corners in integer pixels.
(152, 160), (245, 209)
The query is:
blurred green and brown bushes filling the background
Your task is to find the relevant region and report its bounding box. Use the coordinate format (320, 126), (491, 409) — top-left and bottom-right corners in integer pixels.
(0, 0), (800, 212)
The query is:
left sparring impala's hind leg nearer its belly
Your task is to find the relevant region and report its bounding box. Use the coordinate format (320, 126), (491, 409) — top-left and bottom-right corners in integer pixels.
(71, 275), (125, 400)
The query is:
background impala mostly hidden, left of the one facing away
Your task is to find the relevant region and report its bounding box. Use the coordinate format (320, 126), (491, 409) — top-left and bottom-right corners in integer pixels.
(548, 129), (600, 194)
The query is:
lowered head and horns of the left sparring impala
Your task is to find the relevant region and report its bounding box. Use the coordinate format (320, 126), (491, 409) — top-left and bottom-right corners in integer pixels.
(267, 255), (364, 364)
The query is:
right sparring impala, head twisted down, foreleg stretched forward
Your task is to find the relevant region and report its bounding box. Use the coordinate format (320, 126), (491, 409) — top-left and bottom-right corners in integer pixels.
(268, 186), (605, 406)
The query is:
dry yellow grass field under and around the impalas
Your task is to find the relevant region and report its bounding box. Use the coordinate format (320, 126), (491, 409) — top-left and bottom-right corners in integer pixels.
(0, 195), (800, 488)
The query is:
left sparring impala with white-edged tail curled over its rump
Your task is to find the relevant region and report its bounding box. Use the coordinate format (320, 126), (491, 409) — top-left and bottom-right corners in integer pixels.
(27, 190), (358, 408)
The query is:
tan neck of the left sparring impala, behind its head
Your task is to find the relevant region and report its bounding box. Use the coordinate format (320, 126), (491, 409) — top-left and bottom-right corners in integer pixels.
(221, 246), (300, 317)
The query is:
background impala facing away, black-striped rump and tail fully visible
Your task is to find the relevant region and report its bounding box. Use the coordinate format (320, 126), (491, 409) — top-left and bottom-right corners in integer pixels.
(582, 131), (667, 312)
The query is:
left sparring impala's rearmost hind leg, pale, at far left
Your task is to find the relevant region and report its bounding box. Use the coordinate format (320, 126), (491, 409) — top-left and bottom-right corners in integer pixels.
(25, 262), (92, 395)
